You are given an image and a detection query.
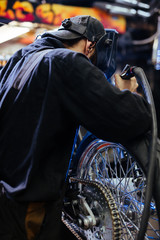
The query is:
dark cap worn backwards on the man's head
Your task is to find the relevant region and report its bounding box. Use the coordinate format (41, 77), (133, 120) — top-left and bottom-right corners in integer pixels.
(45, 15), (105, 42)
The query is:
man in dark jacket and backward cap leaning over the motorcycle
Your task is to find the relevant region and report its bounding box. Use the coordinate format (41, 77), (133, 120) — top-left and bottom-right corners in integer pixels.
(0, 16), (151, 240)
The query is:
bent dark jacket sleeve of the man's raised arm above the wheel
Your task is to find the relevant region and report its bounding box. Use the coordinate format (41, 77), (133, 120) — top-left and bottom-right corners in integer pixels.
(53, 50), (152, 143)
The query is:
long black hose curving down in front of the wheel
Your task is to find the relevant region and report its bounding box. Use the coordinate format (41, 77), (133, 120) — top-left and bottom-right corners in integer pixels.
(133, 67), (157, 240)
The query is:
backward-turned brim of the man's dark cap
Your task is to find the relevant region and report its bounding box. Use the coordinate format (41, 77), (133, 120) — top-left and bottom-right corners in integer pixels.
(48, 30), (81, 40)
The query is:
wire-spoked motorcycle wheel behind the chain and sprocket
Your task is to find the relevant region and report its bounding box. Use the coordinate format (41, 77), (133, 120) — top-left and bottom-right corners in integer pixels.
(77, 139), (160, 240)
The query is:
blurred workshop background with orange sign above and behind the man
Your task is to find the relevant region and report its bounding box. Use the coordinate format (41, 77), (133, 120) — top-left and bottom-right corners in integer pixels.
(0, 0), (160, 137)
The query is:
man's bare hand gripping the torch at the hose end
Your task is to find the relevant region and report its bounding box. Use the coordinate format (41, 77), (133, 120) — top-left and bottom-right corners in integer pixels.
(115, 74), (138, 92)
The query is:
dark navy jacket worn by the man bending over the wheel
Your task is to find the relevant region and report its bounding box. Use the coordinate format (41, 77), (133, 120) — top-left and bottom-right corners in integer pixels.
(0, 35), (151, 201)
